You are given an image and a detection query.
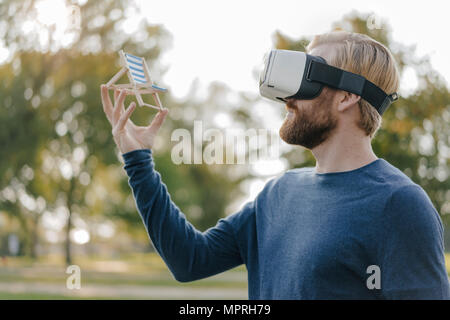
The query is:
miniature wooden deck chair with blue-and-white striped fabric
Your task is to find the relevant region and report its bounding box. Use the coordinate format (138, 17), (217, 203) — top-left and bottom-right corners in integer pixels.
(106, 50), (167, 110)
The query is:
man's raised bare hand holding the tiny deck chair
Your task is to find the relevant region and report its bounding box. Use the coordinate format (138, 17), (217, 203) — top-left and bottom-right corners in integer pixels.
(101, 85), (169, 153)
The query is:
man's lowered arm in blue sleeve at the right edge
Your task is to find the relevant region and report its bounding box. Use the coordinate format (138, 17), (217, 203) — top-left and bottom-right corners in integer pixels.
(380, 185), (450, 299)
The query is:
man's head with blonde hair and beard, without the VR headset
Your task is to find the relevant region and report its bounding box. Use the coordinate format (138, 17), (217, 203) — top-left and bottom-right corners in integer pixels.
(280, 31), (399, 149)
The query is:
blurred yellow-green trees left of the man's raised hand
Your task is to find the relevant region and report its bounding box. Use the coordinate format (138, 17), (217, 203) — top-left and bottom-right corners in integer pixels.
(0, 1), (175, 264)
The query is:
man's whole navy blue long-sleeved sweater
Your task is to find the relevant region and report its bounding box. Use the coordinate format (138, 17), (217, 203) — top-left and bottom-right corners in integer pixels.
(122, 149), (450, 299)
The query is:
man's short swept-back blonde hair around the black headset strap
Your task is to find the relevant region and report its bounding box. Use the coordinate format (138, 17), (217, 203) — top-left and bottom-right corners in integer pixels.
(307, 31), (400, 138)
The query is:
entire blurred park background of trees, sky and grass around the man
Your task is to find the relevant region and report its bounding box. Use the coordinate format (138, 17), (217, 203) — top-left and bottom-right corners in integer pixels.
(0, 0), (450, 299)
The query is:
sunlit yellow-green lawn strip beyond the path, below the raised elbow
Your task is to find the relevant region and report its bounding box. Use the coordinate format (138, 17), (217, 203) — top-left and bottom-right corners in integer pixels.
(0, 253), (247, 288)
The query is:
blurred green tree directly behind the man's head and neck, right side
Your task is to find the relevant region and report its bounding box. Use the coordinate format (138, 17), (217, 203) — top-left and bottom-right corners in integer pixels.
(275, 12), (450, 238)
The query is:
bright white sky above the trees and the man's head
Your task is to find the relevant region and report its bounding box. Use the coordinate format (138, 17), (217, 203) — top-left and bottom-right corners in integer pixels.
(137, 0), (450, 98)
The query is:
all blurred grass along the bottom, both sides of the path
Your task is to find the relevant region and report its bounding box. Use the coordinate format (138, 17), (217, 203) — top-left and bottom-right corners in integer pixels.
(0, 253), (450, 300)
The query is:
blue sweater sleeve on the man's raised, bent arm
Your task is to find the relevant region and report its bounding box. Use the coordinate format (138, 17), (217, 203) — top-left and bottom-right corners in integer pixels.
(122, 149), (248, 282)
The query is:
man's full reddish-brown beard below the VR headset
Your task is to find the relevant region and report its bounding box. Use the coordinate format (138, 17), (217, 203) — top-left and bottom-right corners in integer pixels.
(279, 87), (337, 150)
